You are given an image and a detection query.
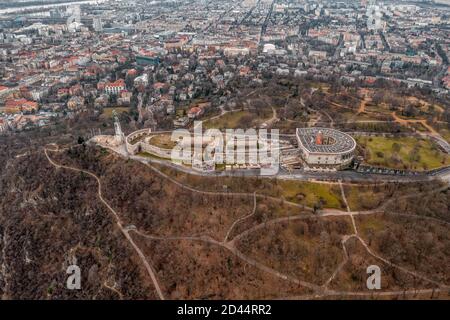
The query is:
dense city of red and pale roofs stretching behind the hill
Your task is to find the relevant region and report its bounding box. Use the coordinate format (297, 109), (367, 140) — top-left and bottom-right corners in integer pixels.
(0, 0), (450, 131)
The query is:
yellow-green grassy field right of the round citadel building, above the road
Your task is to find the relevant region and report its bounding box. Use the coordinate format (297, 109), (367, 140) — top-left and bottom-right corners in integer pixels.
(356, 137), (450, 170)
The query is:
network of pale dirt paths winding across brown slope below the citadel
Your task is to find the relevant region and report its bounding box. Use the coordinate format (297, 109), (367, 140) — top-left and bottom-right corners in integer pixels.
(44, 145), (448, 299)
